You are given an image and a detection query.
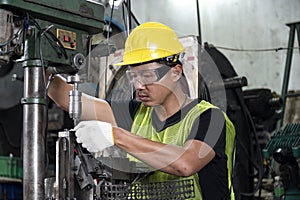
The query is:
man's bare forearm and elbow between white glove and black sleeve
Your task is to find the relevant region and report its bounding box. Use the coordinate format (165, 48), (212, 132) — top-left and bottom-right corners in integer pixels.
(113, 127), (215, 177)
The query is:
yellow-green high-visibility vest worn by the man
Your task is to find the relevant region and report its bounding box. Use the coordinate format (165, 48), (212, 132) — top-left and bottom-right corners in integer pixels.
(128, 100), (235, 200)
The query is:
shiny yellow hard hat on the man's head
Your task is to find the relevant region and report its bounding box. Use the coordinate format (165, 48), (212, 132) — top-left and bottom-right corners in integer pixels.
(114, 22), (184, 66)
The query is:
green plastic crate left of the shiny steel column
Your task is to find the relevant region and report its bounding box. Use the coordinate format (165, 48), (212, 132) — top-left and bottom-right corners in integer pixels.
(0, 156), (23, 179)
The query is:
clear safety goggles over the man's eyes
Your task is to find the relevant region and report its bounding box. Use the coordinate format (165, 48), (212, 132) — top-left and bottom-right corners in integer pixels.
(126, 65), (171, 85)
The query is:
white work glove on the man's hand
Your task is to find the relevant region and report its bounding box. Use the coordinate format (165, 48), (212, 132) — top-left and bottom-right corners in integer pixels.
(74, 121), (114, 152)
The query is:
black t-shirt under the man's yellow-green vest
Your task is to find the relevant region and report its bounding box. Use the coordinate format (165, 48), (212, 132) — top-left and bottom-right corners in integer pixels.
(109, 99), (229, 200)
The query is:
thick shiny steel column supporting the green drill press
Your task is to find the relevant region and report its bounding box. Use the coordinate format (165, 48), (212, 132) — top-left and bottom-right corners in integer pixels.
(22, 60), (47, 200)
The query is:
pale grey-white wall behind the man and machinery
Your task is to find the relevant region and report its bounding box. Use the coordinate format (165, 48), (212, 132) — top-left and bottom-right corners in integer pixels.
(131, 0), (300, 93)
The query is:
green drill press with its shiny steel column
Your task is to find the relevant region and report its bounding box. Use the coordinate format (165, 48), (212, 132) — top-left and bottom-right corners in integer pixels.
(0, 0), (104, 200)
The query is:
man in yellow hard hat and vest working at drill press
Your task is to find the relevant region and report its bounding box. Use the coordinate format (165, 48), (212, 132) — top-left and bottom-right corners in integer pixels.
(48, 22), (235, 200)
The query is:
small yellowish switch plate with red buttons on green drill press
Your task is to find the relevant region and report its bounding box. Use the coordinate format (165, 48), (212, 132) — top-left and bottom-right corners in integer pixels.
(56, 29), (76, 50)
